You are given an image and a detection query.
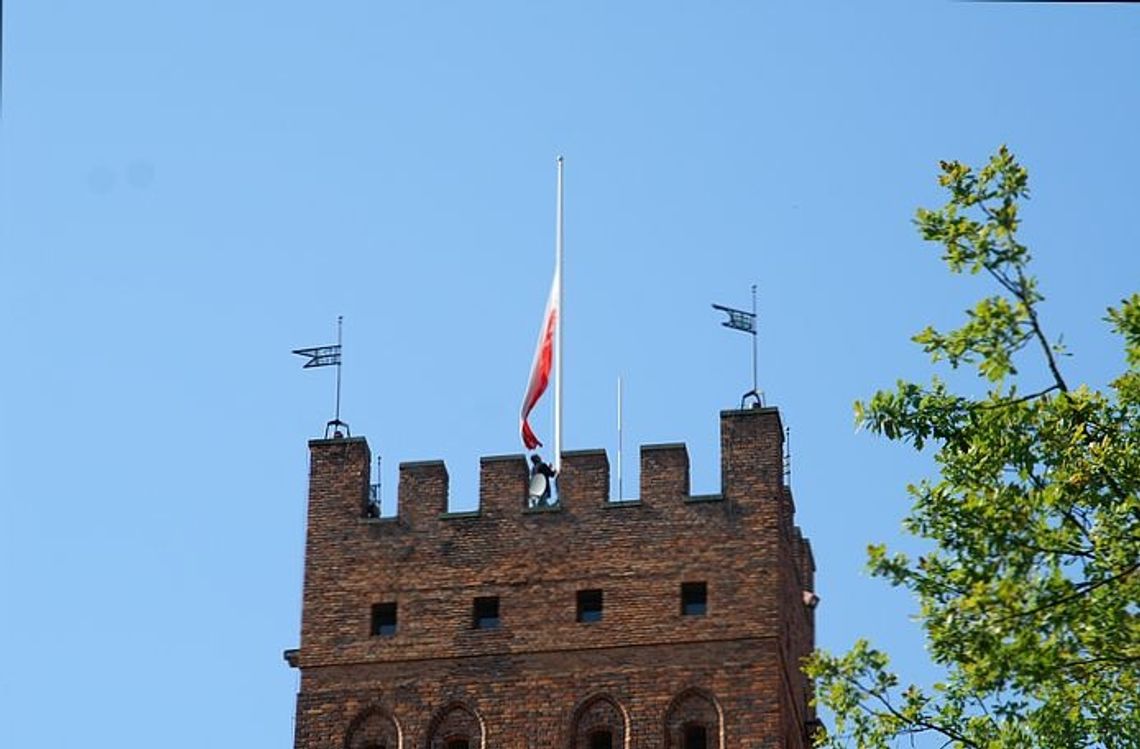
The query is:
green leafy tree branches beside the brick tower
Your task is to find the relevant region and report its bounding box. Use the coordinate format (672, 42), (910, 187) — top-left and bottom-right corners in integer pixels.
(808, 147), (1140, 749)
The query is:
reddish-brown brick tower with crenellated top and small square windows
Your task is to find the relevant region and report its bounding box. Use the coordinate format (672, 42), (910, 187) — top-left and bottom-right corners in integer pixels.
(286, 408), (817, 749)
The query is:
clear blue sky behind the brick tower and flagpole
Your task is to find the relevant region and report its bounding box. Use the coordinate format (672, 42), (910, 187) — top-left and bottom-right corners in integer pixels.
(0, 0), (1140, 749)
